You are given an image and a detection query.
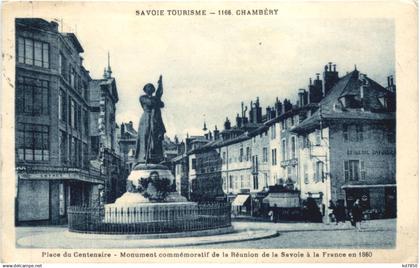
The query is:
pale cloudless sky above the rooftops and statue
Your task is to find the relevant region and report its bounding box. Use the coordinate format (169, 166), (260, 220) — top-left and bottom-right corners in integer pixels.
(35, 3), (395, 141)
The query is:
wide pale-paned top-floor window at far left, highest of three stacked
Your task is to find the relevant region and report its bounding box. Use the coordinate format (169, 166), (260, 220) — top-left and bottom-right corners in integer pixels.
(17, 37), (50, 68)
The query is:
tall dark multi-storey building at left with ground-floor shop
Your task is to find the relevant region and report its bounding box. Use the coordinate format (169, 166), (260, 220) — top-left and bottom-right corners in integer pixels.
(15, 19), (104, 224)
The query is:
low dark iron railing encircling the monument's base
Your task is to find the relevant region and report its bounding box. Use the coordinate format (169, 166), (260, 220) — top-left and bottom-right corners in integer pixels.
(68, 203), (231, 234)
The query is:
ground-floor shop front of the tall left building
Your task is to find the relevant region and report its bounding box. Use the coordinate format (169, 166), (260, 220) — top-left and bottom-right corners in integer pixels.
(15, 167), (103, 225)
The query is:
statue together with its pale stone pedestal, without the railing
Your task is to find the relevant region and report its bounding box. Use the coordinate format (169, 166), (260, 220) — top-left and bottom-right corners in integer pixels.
(111, 76), (187, 205)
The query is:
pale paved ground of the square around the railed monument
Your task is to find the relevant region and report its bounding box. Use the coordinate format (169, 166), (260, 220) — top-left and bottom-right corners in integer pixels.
(16, 219), (396, 248)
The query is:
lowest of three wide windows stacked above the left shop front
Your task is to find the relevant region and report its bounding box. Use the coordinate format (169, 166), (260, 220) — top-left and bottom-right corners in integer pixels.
(16, 124), (50, 161)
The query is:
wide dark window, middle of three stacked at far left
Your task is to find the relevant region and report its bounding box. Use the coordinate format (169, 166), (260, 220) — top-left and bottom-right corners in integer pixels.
(16, 77), (49, 116)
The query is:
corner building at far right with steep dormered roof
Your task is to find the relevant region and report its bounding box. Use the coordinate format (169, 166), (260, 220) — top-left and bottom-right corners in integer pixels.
(292, 70), (396, 220)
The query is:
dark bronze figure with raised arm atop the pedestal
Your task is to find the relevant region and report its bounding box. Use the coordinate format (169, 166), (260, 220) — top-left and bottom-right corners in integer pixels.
(135, 75), (166, 164)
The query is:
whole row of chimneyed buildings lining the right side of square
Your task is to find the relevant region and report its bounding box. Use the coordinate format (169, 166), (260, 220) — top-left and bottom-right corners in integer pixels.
(182, 63), (396, 222)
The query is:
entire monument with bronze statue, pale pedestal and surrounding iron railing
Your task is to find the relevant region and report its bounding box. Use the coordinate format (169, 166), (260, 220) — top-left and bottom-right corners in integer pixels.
(68, 76), (233, 234)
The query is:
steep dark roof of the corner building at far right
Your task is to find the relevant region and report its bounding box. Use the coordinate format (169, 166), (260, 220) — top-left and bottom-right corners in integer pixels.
(292, 70), (395, 132)
